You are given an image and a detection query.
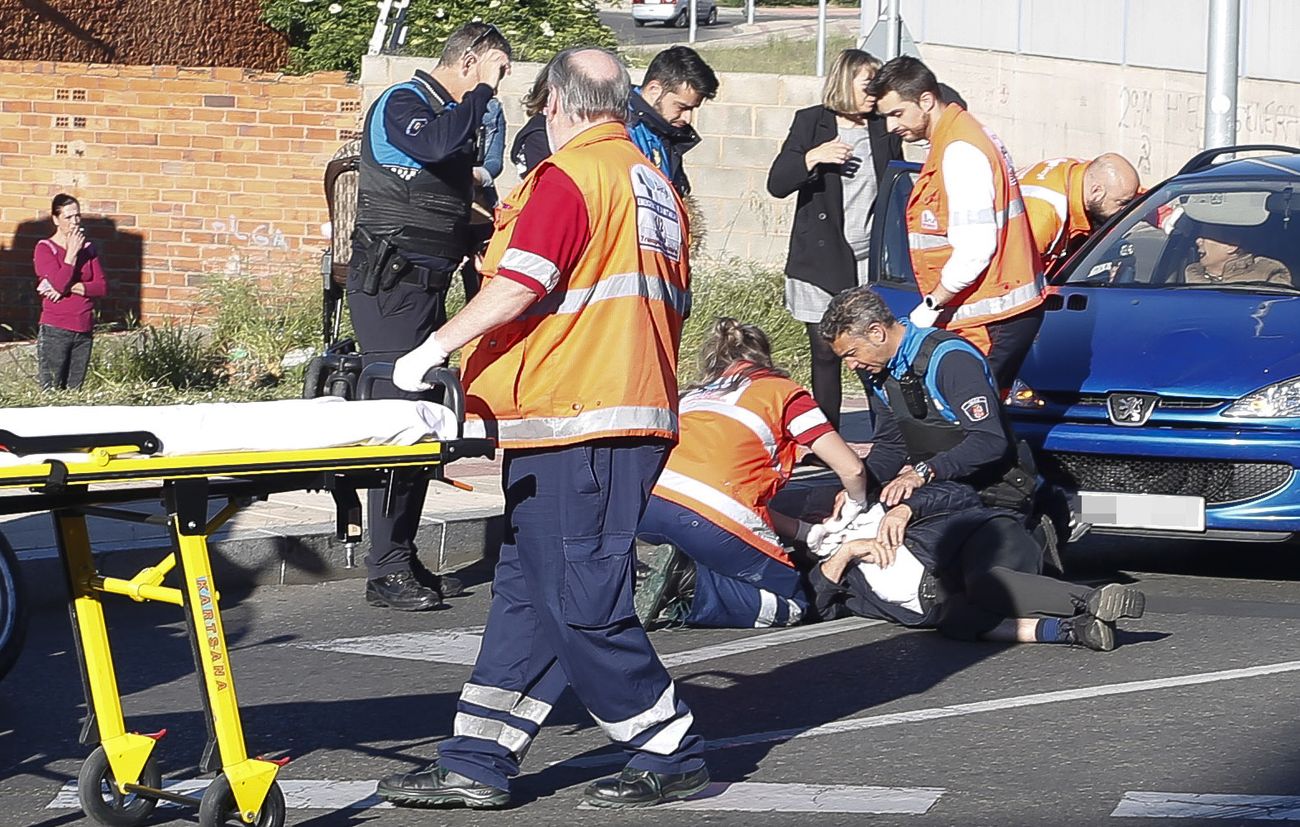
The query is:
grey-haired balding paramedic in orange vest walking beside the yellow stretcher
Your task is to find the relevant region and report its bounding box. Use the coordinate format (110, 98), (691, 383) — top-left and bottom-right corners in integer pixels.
(378, 48), (709, 807)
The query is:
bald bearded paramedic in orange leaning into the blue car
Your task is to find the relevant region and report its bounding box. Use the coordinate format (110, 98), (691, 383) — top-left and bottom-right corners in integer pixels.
(1019, 152), (1141, 276)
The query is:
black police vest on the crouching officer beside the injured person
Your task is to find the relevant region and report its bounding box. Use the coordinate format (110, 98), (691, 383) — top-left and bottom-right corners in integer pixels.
(878, 330), (1036, 507)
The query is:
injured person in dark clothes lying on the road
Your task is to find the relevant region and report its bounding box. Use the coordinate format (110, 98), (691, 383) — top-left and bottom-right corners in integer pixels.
(809, 481), (1147, 651)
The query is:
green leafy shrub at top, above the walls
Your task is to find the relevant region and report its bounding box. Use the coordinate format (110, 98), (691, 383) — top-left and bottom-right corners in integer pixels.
(263, 0), (616, 75)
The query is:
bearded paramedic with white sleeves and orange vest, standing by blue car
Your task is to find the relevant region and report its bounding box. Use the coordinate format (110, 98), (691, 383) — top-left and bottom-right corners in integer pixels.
(871, 56), (1044, 390)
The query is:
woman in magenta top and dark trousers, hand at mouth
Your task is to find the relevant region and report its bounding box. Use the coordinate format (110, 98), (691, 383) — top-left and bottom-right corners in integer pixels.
(33, 192), (108, 389)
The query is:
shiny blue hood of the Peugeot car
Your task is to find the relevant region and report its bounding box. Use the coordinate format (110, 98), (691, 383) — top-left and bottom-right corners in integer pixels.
(1021, 287), (1300, 398)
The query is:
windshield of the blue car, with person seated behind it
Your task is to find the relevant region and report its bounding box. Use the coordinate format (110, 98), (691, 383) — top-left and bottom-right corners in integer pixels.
(1066, 181), (1300, 293)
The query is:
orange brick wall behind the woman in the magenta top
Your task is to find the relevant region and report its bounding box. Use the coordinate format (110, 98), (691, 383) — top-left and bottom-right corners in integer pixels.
(0, 61), (360, 333)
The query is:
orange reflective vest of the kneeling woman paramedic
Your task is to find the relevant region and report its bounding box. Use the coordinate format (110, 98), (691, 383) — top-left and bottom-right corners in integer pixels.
(654, 372), (807, 567)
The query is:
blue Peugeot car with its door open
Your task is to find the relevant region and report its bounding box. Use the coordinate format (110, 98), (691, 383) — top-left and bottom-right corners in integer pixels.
(871, 147), (1300, 541)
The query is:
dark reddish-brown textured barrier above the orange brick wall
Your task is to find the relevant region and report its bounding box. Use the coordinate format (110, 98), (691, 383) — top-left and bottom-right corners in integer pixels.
(0, 0), (289, 72)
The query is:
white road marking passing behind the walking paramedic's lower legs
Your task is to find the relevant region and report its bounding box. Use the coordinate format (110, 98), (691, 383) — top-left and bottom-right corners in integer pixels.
(292, 618), (884, 668)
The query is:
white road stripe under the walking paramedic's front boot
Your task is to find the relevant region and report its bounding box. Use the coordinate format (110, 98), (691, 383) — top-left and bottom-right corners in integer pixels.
(579, 781), (945, 815)
